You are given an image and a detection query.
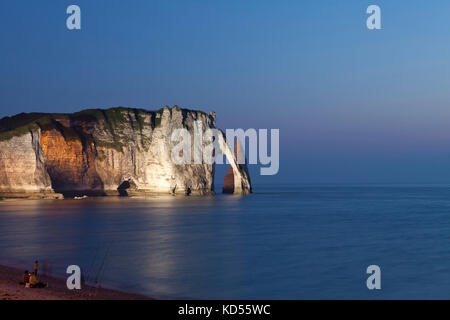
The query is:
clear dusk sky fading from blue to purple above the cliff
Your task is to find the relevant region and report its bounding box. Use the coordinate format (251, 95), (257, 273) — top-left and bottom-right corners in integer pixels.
(0, 0), (450, 183)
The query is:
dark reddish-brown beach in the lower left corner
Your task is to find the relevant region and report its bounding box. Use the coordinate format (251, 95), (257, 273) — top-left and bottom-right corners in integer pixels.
(0, 266), (150, 300)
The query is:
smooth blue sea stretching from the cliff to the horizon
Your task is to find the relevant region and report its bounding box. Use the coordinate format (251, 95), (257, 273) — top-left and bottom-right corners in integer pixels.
(0, 185), (450, 299)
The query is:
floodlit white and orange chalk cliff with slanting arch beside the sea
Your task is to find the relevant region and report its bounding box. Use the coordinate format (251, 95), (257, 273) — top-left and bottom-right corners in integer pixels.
(0, 107), (251, 196)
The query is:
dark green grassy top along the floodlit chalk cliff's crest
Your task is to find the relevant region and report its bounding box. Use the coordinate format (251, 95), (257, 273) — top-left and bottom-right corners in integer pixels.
(0, 106), (206, 141)
